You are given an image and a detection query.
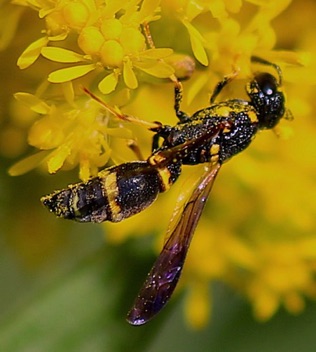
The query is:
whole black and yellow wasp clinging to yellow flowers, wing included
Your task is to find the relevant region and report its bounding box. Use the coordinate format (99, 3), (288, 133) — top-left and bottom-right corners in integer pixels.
(41, 57), (286, 325)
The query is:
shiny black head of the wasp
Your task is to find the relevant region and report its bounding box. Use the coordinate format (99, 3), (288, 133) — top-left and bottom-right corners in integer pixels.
(247, 73), (285, 129)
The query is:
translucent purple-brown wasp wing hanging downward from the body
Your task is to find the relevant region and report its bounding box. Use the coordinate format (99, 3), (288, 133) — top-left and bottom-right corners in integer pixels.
(127, 164), (220, 325)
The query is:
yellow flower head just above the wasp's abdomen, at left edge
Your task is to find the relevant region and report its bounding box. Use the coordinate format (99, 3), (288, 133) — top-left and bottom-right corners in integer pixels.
(10, 83), (133, 180)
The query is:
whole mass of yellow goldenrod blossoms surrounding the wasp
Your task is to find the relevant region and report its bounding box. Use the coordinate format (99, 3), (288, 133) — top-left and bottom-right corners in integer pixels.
(3, 0), (316, 328)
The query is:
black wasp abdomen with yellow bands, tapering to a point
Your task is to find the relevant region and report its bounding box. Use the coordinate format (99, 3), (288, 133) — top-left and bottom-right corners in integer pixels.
(41, 161), (178, 222)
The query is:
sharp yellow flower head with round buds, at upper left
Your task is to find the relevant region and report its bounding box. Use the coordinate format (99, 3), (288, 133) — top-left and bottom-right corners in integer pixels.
(18, 0), (173, 94)
